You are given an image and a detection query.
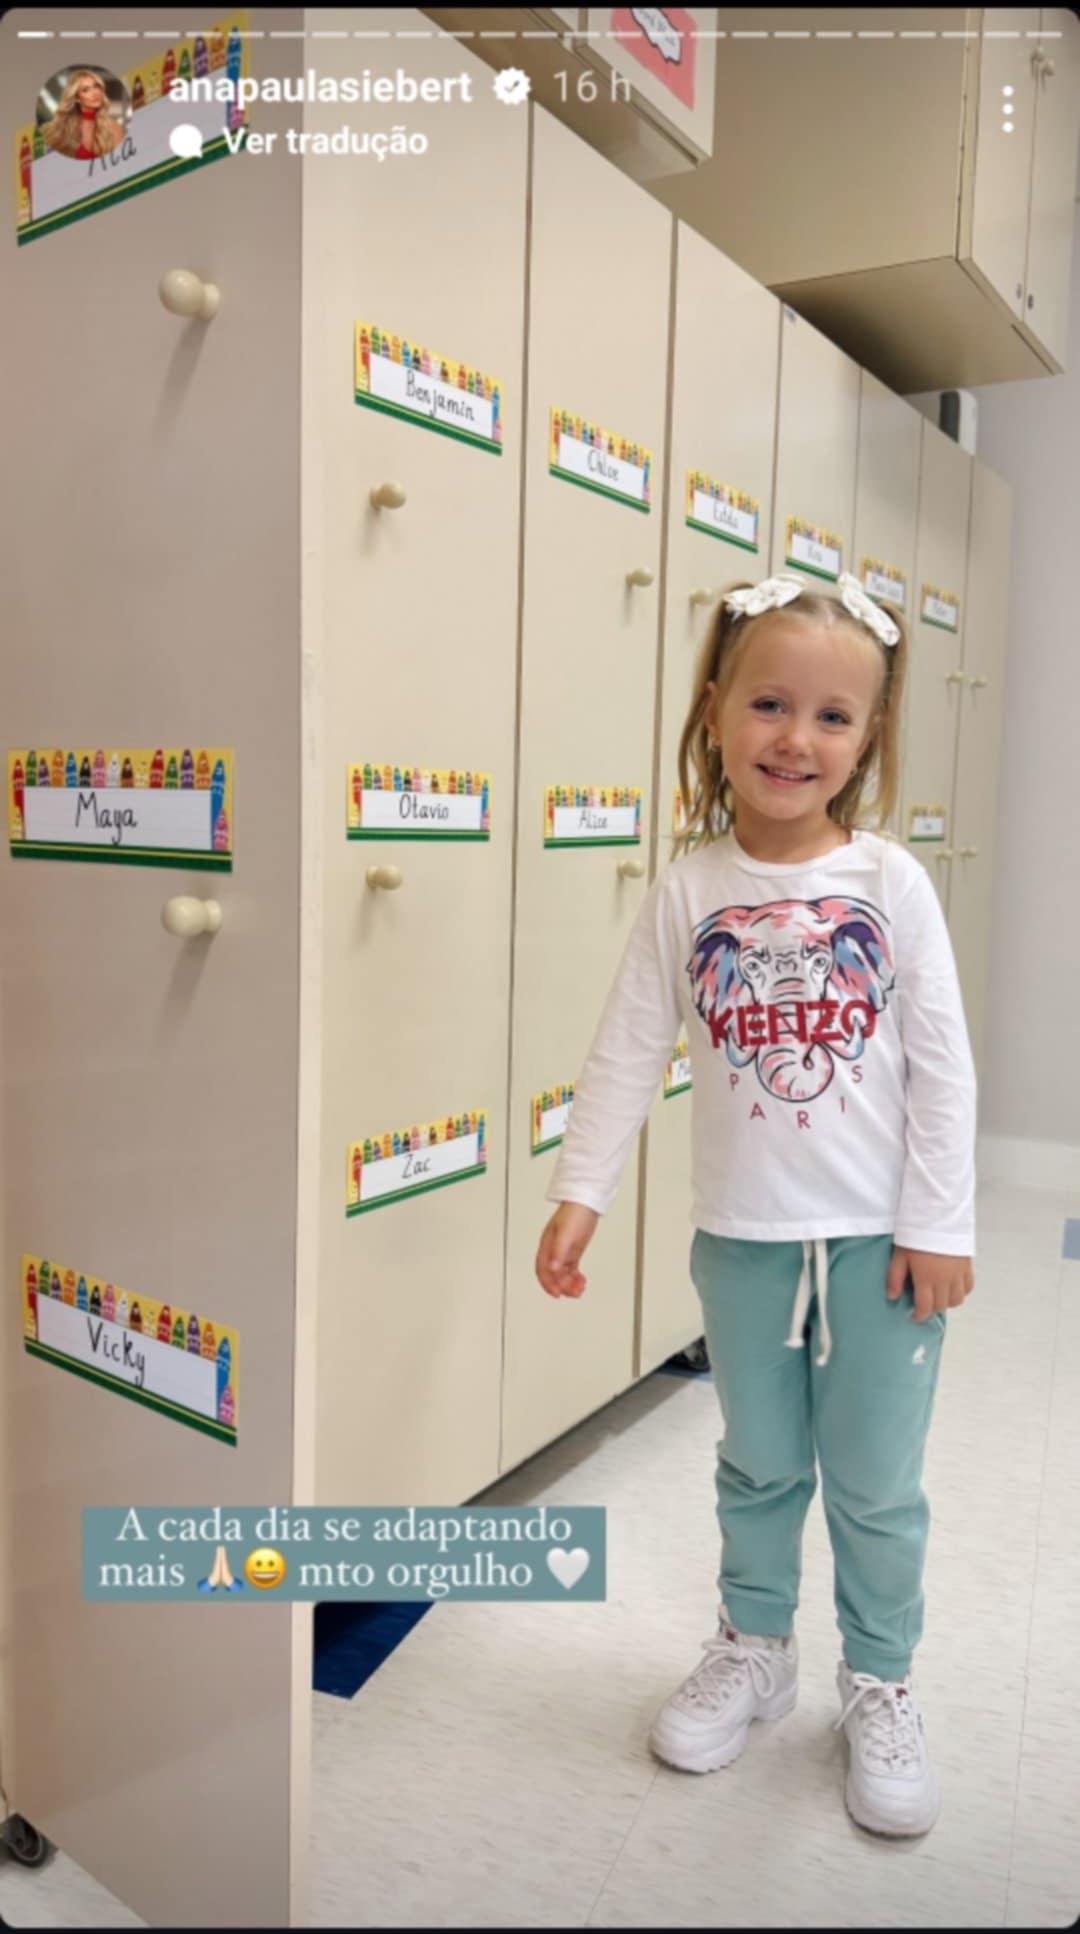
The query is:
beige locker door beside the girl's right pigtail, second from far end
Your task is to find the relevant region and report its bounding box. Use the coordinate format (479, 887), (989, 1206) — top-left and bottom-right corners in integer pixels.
(900, 418), (972, 907)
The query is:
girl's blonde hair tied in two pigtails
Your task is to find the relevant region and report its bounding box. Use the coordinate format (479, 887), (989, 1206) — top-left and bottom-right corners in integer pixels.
(672, 578), (908, 859)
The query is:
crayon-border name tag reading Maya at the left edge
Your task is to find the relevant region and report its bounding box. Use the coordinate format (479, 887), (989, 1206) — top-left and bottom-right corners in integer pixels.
(8, 747), (234, 872)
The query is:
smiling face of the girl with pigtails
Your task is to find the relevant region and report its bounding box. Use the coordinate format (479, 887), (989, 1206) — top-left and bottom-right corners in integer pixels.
(706, 613), (883, 837)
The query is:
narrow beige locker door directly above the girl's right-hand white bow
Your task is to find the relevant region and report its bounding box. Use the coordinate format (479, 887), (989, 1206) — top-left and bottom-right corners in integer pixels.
(854, 369), (921, 835)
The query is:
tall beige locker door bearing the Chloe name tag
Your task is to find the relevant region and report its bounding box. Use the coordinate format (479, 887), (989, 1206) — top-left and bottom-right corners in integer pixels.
(501, 108), (674, 1470)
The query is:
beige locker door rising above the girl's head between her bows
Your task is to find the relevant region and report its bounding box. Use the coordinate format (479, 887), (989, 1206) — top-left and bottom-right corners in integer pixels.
(770, 304), (859, 590)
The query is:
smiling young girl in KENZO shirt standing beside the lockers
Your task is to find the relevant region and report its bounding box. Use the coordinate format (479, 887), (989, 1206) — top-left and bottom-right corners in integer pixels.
(536, 574), (975, 1833)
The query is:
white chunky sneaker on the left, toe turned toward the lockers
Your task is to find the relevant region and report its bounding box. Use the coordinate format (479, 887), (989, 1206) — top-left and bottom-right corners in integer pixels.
(648, 1619), (799, 1773)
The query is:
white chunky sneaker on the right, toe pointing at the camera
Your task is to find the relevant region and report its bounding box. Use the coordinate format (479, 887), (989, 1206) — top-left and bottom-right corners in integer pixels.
(834, 1659), (941, 1833)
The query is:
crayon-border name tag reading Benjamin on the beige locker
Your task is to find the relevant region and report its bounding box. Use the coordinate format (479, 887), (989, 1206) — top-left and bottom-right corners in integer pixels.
(352, 321), (503, 456)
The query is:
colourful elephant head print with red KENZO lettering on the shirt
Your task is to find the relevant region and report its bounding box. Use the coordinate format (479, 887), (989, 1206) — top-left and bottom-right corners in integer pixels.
(685, 894), (896, 1102)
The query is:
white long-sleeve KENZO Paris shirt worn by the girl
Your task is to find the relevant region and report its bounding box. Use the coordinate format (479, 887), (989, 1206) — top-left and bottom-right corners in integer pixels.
(548, 830), (975, 1269)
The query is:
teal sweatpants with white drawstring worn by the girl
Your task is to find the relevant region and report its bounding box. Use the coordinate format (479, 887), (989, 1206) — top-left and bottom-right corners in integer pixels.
(691, 1230), (946, 1679)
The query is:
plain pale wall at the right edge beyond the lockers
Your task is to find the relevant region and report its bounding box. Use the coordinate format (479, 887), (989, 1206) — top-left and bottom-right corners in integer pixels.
(910, 220), (1080, 1182)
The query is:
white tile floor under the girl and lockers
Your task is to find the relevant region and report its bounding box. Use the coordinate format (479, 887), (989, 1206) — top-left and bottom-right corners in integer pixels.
(0, 1186), (1080, 1928)
